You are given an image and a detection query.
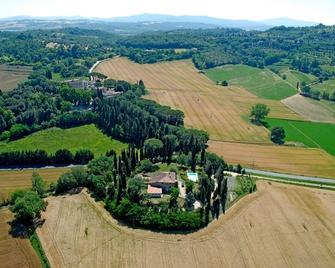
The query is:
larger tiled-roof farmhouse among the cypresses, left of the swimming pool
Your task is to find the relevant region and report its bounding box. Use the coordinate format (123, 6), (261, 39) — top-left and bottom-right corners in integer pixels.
(148, 172), (178, 194)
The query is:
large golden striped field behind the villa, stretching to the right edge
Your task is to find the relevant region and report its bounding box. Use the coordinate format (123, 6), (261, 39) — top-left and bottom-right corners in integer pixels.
(96, 58), (335, 177)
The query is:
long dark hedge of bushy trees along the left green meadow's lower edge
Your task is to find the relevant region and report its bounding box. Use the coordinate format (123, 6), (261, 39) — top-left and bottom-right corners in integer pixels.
(0, 149), (94, 166)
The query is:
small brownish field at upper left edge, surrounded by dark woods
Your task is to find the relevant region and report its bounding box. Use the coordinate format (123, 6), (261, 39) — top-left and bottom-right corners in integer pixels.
(0, 65), (31, 91)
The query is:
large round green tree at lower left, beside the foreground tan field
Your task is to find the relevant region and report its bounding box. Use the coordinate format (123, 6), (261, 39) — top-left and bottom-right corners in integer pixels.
(12, 191), (46, 224)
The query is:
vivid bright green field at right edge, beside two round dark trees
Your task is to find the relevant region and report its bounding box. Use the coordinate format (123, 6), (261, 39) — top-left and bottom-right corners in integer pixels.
(265, 118), (335, 156)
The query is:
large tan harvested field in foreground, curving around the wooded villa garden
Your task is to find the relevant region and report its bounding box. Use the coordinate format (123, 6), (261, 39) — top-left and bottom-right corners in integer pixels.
(37, 182), (335, 268)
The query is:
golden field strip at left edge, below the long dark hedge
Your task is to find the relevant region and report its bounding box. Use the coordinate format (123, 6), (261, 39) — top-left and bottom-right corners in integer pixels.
(0, 168), (70, 199)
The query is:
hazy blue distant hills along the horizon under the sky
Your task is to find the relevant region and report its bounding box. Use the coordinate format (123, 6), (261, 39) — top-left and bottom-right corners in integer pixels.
(0, 14), (318, 35)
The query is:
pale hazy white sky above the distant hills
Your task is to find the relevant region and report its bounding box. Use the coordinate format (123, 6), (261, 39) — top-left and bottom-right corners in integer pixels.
(0, 0), (335, 24)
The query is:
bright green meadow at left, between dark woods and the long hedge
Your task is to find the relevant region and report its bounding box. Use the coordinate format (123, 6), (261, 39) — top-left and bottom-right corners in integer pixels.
(0, 125), (126, 156)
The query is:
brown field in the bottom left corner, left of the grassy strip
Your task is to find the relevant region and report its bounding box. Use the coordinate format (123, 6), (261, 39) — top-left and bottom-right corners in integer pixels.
(0, 208), (41, 268)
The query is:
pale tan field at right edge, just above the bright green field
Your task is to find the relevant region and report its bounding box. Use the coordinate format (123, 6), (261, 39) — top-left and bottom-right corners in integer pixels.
(282, 94), (335, 123)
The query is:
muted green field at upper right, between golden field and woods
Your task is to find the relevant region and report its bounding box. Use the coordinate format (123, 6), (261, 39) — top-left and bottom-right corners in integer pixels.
(206, 64), (297, 100)
